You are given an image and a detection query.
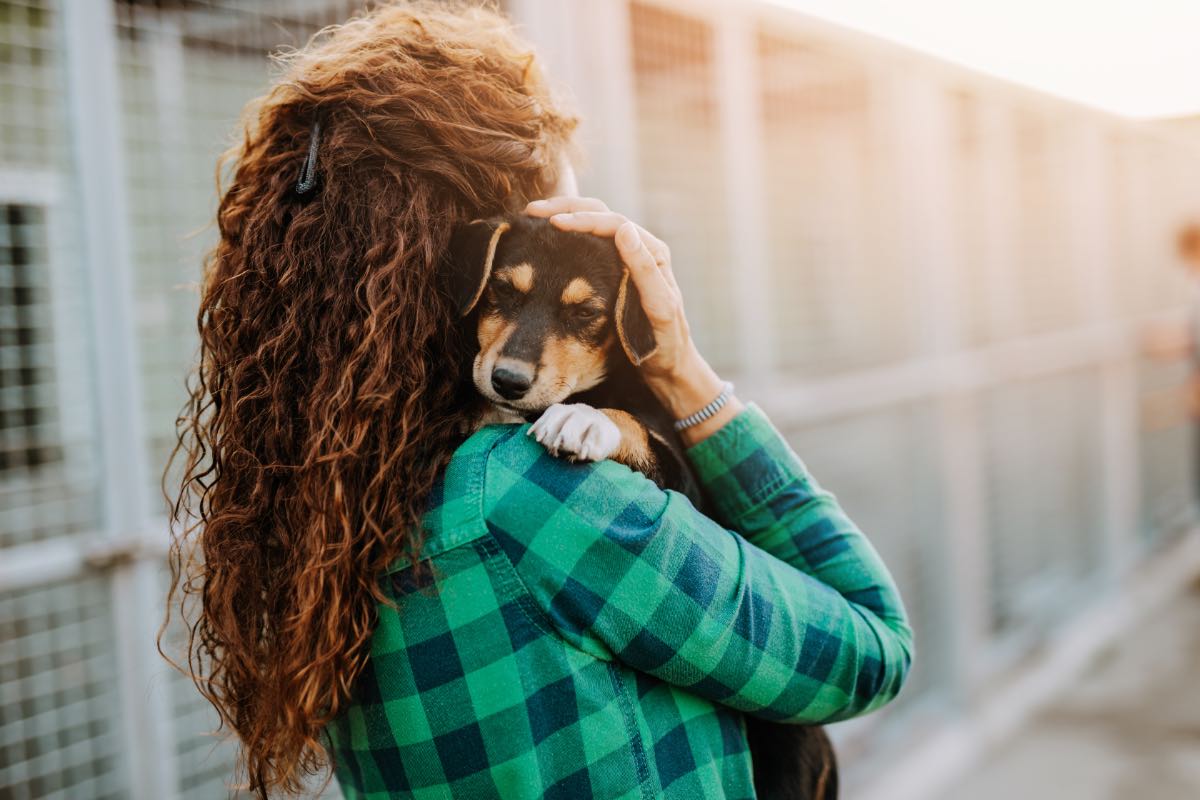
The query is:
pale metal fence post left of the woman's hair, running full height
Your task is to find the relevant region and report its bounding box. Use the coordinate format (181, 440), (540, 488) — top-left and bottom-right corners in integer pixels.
(62, 0), (178, 800)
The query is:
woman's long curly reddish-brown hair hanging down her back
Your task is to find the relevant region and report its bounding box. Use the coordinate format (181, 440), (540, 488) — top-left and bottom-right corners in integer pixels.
(160, 0), (577, 798)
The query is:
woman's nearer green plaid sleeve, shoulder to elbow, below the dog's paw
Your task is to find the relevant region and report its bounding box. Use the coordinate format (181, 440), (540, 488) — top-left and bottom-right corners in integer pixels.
(484, 412), (911, 722)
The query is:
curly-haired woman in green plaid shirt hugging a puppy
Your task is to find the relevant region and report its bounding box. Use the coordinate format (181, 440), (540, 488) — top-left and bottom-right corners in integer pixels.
(164, 2), (911, 798)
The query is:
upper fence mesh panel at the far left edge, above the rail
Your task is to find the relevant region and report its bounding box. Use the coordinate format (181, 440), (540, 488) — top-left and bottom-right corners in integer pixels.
(0, 1), (97, 547)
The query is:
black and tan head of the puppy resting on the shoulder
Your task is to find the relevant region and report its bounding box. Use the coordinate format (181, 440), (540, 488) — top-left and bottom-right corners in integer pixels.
(448, 213), (654, 411)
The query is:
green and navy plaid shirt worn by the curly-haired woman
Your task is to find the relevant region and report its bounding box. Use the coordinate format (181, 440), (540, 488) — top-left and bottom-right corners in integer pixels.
(326, 405), (912, 800)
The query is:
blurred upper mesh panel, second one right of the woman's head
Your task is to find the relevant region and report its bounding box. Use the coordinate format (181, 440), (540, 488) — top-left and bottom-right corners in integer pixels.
(757, 32), (914, 375)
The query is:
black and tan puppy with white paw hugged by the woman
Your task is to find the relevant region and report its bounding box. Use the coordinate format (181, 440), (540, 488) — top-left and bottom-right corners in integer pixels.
(448, 213), (838, 800)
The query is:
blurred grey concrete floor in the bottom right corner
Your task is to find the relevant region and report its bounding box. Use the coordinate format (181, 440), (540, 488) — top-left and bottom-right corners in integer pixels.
(941, 581), (1200, 800)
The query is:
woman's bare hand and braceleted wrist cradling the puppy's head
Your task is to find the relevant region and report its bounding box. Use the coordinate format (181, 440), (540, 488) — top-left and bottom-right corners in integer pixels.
(526, 197), (742, 444)
